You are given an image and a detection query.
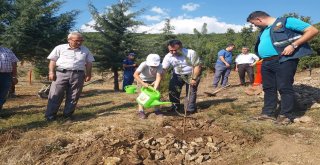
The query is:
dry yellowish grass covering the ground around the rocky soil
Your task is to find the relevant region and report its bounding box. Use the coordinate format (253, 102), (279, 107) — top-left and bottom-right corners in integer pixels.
(0, 65), (320, 164)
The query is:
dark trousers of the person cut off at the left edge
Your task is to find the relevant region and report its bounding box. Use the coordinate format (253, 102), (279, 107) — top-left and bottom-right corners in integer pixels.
(0, 73), (12, 109)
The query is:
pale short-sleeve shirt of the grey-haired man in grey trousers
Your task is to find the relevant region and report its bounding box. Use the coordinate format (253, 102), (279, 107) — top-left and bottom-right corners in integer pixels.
(47, 44), (94, 70)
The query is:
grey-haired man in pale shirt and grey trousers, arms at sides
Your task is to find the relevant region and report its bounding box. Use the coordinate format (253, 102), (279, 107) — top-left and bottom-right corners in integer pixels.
(45, 32), (94, 121)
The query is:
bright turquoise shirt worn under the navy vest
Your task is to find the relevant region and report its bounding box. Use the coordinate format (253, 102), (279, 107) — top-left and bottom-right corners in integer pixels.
(258, 17), (311, 58)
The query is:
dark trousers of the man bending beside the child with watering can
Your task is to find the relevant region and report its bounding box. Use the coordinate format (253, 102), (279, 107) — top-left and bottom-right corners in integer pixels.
(169, 73), (200, 112)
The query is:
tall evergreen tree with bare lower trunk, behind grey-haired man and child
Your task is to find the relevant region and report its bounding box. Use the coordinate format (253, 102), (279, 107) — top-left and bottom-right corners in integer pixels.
(89, 0), (142, 91)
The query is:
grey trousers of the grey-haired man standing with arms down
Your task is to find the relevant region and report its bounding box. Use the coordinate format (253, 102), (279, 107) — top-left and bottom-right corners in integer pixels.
(45, 71), (85, 119)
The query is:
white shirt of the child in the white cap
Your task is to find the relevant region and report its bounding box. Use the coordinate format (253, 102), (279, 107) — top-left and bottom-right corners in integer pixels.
(136, 61), (162, 81)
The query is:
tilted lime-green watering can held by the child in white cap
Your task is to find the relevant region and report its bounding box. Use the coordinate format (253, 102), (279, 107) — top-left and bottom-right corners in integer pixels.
(137, 87), (171, 108)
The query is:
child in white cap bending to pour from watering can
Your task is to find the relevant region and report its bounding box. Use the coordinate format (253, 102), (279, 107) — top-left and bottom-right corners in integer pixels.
(133, 54), (162, 119)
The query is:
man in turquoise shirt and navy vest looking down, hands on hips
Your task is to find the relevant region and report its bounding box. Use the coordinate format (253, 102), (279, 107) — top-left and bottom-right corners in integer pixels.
(247, 11), (318, 124)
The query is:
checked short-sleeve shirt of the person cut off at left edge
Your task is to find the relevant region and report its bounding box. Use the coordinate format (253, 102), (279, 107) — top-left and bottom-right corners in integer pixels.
(0, 46), (19, 73)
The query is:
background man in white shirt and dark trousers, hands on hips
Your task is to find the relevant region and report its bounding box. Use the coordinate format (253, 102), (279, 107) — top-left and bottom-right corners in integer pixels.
(235, 46), (259, 85)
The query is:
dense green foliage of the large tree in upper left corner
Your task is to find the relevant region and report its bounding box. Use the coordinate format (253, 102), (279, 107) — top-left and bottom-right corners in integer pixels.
(0, 0), (78, 77)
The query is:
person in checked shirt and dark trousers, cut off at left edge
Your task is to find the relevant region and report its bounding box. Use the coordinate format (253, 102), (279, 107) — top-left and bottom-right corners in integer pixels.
(0, 46), (19, 111)
